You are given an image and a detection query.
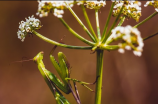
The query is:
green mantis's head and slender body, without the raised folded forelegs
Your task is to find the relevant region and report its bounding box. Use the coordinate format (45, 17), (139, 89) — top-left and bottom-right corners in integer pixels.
(33, 52), (70, 104)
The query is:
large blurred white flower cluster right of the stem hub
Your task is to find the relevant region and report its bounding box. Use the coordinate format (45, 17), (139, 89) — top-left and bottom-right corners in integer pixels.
(111, 25), (144, 56)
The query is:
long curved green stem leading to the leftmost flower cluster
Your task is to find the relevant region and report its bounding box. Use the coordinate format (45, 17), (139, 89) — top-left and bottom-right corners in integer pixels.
(32, 31), (92, 49)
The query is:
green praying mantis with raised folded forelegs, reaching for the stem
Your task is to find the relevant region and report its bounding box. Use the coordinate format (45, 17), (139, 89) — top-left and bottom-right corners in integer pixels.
(33, 46), (96, 104)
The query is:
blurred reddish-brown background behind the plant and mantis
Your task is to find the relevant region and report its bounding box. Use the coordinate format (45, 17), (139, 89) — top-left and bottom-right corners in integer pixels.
(0, 1), (158, 104)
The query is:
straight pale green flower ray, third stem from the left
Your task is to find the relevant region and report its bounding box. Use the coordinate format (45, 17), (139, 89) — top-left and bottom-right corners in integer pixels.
(68, 6), (96, 42)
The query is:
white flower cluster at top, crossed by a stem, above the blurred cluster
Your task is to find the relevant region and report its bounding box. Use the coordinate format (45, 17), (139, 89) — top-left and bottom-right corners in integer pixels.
(113, 0), (141, 22)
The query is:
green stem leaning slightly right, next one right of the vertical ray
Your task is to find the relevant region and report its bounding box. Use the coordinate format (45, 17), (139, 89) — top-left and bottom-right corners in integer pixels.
(102, 2), (115, 40)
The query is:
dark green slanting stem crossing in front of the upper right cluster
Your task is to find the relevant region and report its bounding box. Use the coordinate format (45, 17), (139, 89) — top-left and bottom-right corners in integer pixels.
(102, 2), (124, 43)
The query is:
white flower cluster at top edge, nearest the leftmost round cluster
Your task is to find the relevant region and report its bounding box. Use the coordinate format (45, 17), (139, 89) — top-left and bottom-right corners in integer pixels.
(36, 0), (74, 18)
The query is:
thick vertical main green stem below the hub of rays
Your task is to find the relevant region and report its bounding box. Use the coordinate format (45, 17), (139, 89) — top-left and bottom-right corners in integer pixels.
(95, 50), (104, 104)
